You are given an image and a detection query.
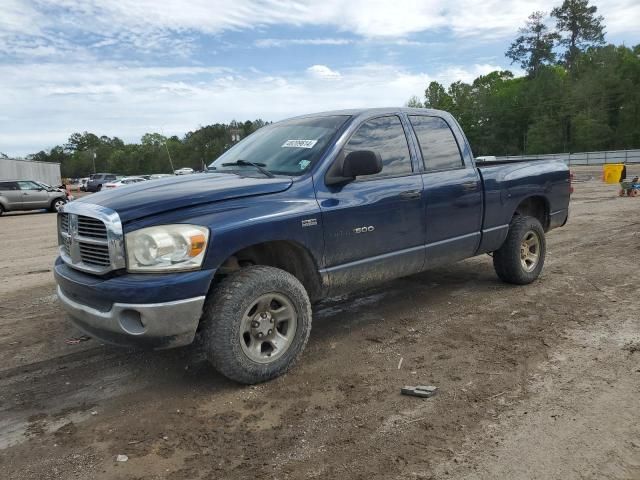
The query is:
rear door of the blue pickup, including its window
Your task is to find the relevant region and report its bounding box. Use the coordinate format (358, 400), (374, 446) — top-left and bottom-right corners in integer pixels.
(409, 115), (482, 268)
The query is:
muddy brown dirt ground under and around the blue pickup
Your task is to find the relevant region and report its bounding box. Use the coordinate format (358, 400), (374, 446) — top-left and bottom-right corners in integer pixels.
(0, 166), (640, 480)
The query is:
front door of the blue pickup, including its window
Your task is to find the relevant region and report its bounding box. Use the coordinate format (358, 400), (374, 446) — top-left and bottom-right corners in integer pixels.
(316, 115), (424, 291)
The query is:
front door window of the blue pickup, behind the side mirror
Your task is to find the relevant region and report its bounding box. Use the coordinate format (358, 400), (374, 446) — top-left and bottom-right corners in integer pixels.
(343, 115), (412, 179)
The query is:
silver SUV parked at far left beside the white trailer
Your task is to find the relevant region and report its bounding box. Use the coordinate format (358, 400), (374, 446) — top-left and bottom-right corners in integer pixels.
(0, 180), (67, 215)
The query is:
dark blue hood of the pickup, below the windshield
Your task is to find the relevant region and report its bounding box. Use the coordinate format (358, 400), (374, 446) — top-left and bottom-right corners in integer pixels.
(76, 173), (292, 223)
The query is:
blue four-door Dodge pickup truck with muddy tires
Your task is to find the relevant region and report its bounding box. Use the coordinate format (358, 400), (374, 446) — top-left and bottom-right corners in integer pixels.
(55, 109), (571, 383)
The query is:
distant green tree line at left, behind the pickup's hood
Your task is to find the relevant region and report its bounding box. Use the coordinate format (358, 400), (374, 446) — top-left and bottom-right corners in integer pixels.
(27, 120), (266, 178)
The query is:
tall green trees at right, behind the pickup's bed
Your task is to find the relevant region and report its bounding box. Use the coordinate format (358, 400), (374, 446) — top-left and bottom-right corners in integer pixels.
(407, 0), (640, 155)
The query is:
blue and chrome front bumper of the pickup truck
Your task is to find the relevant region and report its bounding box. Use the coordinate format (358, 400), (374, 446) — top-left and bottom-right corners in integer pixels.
(54, 258), (215, 349)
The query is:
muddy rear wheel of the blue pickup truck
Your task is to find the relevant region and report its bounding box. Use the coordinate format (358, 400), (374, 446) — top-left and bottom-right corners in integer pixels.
(493, 216), (547, 285)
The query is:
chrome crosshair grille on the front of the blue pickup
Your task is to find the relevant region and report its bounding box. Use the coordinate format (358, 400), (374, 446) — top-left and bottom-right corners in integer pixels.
(58, 202), (125, 274)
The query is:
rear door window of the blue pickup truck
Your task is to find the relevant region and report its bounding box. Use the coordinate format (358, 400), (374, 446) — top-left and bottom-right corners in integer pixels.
(409, 115), (464, 171)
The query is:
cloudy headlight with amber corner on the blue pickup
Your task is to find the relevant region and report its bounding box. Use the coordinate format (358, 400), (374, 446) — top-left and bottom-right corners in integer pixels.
(125, 224), (209, 272)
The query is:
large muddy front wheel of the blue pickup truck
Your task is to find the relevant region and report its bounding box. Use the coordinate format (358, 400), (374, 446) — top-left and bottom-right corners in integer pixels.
(202, 266), (311, 384)
